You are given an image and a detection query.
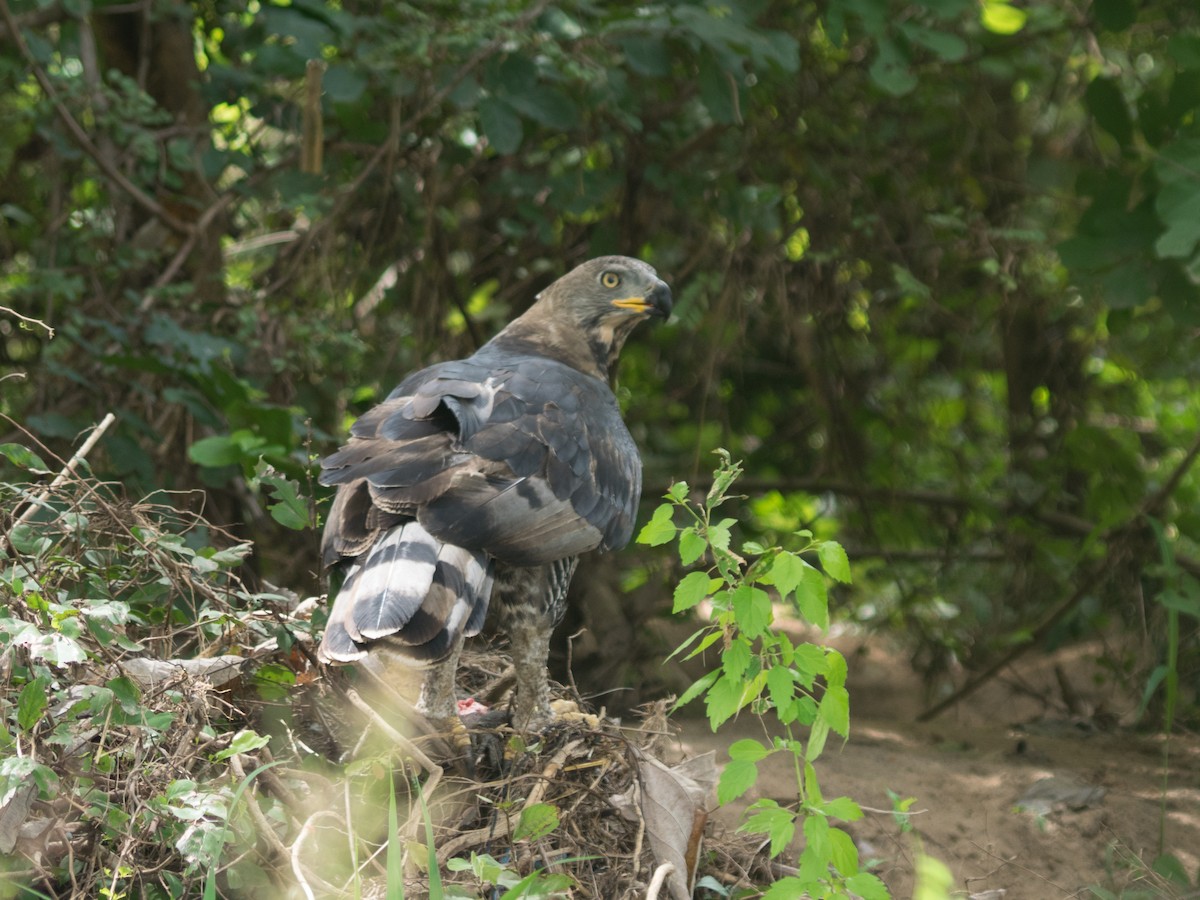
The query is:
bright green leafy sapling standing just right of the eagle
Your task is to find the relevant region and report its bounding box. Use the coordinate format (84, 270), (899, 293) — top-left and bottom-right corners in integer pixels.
(637, 450), (888, 900)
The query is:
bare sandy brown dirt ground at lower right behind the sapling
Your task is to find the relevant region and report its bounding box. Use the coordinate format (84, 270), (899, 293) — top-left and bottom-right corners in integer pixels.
(680, 638), (1200, 900)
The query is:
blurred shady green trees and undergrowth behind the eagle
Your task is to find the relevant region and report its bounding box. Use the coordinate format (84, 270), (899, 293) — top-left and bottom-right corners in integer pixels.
(0, 0), (1200, 721)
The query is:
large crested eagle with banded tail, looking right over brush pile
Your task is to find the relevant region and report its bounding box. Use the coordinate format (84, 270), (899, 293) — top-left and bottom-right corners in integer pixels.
(318, 257), (671, 730)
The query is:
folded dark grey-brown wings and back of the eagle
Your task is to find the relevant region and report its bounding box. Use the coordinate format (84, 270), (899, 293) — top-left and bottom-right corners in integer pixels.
(320, 348), (641, 565)
